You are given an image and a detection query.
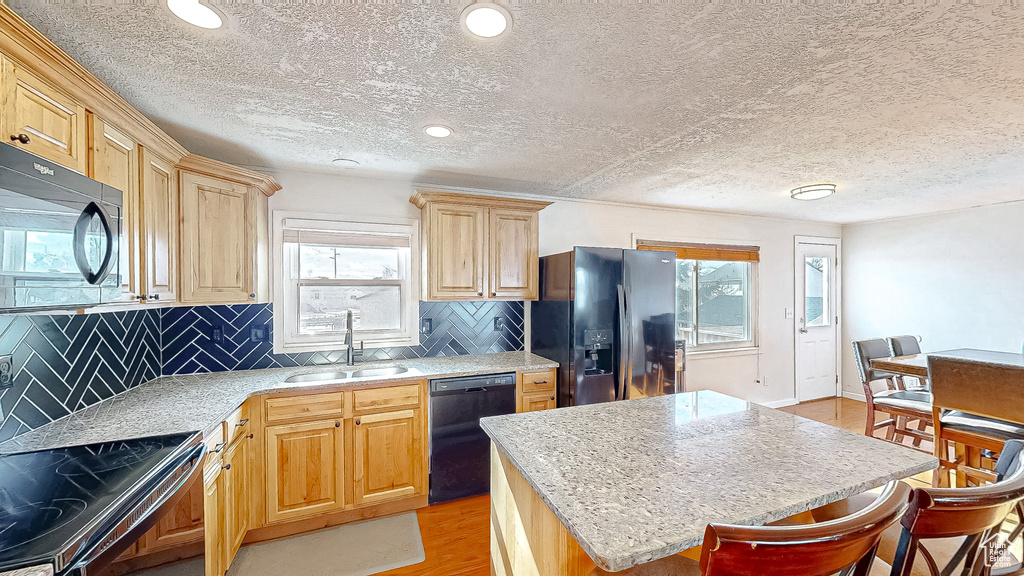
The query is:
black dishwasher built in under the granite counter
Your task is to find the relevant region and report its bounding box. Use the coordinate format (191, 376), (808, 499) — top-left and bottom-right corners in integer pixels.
(428, 374), (515, 503)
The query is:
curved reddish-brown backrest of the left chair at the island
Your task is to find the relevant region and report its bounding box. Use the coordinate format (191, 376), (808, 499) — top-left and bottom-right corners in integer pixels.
(700, 482), (910, 576)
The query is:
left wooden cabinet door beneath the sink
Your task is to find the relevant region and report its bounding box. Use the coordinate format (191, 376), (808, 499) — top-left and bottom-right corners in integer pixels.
(264, 419), (345, 522)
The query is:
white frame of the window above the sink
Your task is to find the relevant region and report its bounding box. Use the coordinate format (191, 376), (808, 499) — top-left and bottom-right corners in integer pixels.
(272, 210), (420, 354)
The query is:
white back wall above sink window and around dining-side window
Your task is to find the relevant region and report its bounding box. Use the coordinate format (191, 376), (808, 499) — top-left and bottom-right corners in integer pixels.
(270, 168), (841, 403)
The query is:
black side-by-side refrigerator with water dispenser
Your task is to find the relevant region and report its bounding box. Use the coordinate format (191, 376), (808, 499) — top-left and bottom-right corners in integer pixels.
(530, 246), (676, 407)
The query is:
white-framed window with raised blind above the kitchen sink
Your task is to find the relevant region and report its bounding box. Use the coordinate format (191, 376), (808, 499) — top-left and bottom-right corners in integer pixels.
(274, 217), (419, 353)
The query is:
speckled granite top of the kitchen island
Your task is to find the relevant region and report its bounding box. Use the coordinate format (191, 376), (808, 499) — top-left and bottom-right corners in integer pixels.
(480, 392), (938, 572)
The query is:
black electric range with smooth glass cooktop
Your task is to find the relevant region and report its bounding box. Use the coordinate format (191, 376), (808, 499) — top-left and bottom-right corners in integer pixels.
(0, 433), (206, 576)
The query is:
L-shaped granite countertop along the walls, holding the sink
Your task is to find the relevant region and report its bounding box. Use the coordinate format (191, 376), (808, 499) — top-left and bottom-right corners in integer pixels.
(0, 352), (558, 454)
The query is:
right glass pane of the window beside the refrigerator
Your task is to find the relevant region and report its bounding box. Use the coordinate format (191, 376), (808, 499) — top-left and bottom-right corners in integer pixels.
(696, 260), (751, 346)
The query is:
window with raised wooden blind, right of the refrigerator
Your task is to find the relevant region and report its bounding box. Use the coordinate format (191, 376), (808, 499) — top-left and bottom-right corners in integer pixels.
(637, 241), (759, 351)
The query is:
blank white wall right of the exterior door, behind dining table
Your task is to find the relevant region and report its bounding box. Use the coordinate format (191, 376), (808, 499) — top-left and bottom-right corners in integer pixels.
(843, 203), (1024, 395)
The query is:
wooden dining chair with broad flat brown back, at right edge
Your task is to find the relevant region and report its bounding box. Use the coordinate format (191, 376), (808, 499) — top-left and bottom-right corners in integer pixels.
(928, 356), (1024, 487)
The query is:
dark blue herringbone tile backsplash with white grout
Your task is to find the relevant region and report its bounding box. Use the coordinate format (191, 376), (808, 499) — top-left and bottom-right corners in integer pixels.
(0, 302), (523, 442)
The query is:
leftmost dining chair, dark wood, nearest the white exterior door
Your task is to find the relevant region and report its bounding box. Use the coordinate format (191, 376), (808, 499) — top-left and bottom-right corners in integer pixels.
(853, 338), (933, 447)
